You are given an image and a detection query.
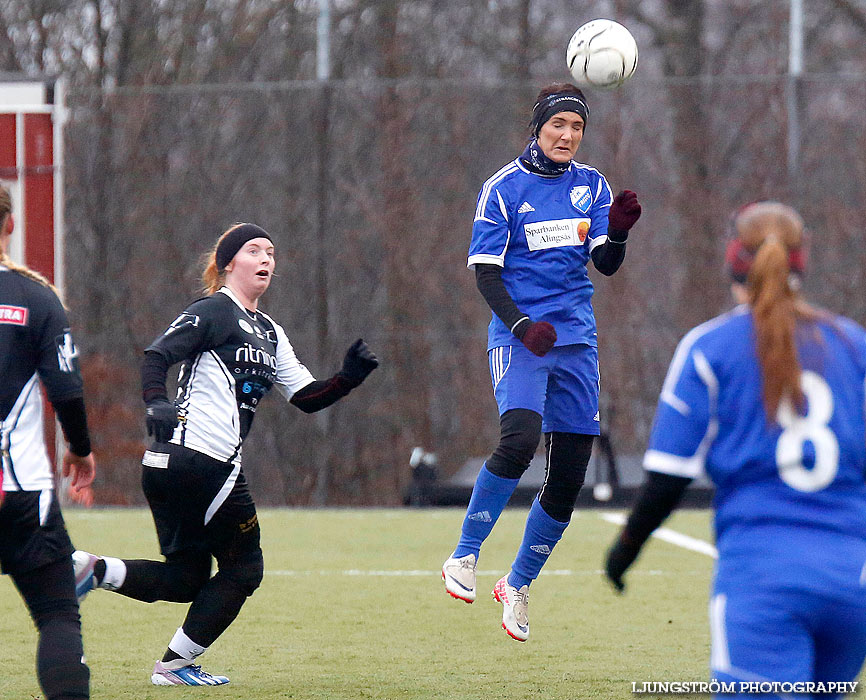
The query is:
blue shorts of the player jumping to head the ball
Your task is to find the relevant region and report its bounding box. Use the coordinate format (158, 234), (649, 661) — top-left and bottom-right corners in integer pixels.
(487, 345), (600, 435)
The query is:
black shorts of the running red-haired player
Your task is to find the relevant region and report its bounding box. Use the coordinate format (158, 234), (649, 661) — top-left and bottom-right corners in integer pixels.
(141, 443), (259, 556)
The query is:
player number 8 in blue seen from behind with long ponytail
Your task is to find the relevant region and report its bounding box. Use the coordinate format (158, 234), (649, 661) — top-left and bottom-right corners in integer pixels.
(606, 202), (866, 697)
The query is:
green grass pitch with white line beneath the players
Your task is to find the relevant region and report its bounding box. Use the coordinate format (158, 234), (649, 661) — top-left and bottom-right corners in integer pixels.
(0, 509), (713, 700)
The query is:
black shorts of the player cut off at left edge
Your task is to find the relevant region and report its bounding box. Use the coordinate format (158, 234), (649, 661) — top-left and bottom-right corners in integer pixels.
(0, 489), (74, 574)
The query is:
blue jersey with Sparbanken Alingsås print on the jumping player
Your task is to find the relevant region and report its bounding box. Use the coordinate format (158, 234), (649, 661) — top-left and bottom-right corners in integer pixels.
(468, 159), (612, 350)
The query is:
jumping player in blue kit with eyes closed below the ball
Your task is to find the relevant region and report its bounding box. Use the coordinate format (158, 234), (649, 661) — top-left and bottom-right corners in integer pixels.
(442, 83), (640, 641)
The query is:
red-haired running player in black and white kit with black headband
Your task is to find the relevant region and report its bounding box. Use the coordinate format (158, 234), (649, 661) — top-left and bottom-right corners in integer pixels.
(75, 224), (378, 685)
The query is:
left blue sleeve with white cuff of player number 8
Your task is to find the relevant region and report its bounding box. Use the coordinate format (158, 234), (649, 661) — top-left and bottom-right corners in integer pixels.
(644, 336), (718, 478)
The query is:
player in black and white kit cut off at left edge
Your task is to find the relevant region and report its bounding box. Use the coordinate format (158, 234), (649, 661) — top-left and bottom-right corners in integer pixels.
(0, 186), (94, 700)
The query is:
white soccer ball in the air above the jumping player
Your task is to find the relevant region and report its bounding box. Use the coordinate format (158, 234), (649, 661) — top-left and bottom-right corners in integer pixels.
(565, 19), (637, 90)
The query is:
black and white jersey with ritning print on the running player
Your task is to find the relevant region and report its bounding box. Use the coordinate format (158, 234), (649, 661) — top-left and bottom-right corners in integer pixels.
(145, 287), (315, 462)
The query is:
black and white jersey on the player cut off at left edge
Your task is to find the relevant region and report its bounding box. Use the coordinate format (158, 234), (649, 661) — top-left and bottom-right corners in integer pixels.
(0, 265), (82, 491)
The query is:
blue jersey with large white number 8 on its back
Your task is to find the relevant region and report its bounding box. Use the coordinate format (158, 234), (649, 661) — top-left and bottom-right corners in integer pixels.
(644, 306), (866, 564)
